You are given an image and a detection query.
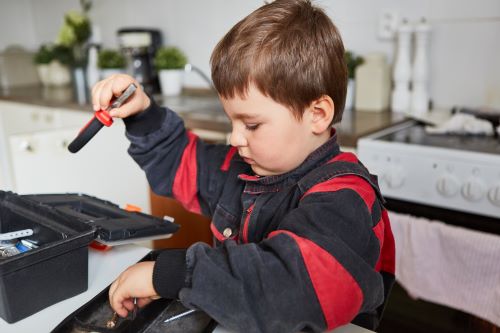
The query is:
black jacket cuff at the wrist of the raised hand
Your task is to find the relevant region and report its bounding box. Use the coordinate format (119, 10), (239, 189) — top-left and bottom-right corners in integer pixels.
(123, 97), (166, 136)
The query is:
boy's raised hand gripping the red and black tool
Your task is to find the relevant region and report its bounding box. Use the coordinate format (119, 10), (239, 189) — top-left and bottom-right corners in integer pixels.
(92, 74), (151, 118)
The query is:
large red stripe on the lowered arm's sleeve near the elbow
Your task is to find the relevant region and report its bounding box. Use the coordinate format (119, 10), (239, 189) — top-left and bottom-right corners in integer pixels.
(269, 230), (363, 330)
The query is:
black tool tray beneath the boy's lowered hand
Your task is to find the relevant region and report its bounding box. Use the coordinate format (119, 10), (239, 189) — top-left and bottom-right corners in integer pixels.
(52, 252), (217, 333)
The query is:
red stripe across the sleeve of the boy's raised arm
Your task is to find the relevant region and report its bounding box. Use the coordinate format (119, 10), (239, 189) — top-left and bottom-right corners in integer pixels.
(172, 131), (201, 213)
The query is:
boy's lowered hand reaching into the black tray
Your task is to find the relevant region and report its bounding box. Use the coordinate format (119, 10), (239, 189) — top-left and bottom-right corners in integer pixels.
(109, 261), (160, 317)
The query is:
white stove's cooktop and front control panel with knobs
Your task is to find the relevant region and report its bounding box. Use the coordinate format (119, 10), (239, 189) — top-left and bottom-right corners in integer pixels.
(358, 120), (500, 219)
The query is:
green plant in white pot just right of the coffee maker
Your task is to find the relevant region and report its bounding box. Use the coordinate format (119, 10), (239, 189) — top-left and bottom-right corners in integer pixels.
(154, 46), (187, 96)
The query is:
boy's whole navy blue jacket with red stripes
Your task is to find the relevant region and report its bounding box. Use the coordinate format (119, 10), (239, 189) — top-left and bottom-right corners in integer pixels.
(125, 103), (395, 333)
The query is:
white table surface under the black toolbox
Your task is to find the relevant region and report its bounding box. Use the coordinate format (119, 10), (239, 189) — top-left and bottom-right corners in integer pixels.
(0, 245), (371, 333)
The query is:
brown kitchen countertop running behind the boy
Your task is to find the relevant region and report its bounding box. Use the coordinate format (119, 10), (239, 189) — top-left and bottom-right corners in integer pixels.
(0, 86), (406, 147)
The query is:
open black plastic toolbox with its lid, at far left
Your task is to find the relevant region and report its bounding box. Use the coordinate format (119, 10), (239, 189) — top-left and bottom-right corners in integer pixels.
(0, 191), (179, 323)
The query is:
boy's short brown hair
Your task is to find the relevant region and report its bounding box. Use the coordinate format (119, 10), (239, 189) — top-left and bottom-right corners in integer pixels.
(210, 0), (347, 123)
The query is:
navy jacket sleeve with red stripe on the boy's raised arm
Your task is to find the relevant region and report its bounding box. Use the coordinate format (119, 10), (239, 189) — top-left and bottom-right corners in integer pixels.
(124, 100), (236, 216)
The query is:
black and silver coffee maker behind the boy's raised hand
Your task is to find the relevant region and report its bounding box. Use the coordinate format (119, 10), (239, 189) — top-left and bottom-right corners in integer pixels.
(118, 28), (162, 94)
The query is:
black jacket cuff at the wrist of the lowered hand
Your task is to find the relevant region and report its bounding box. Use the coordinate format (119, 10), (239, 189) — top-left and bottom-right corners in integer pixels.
(153, 249), (186, 299)
